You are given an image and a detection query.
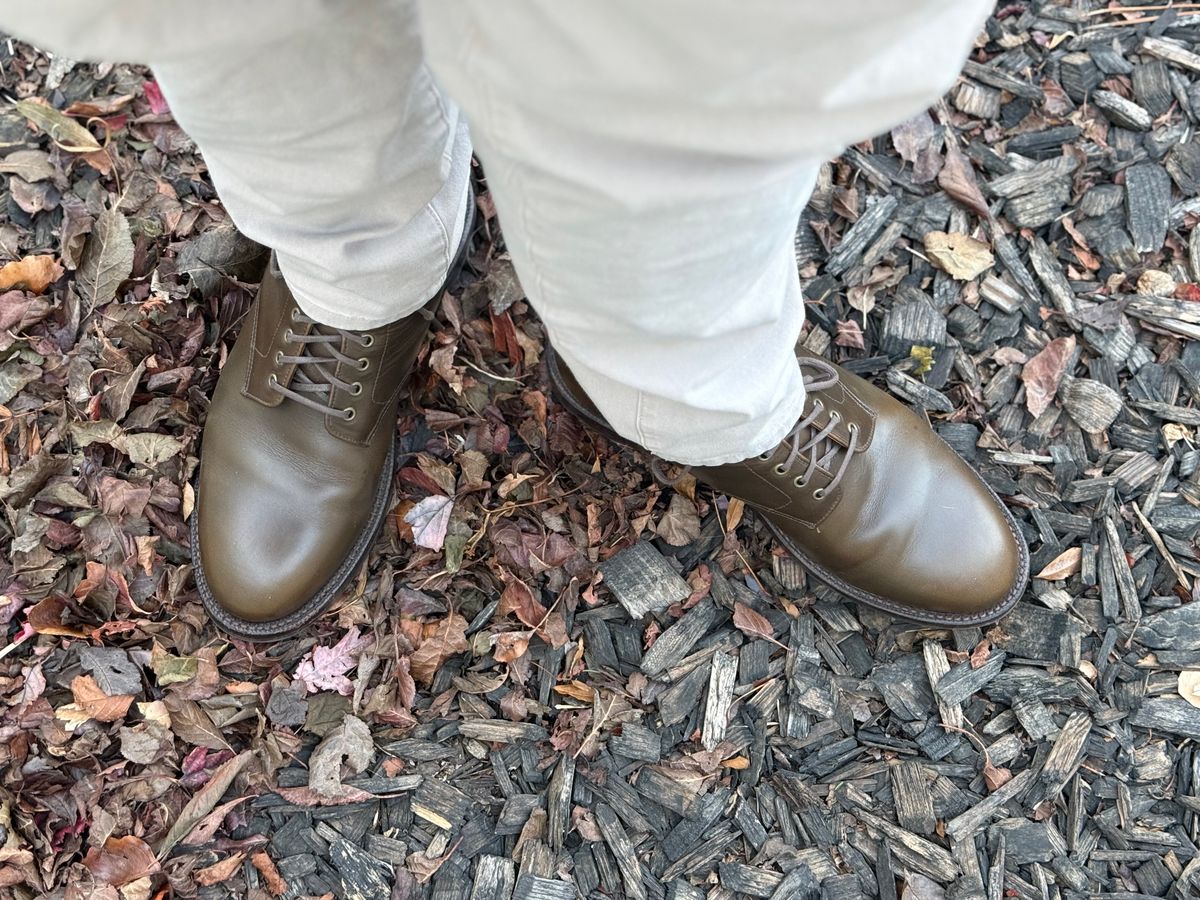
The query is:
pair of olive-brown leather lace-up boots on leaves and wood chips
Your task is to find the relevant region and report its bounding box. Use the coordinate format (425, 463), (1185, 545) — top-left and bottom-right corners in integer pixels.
(191, 266), (1028, 640)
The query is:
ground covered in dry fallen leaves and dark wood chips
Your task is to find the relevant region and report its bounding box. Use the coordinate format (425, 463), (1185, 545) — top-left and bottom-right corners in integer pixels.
(11, 0), (1200, 900)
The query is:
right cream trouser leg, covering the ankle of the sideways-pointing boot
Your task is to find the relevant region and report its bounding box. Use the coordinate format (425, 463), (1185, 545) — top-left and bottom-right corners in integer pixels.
(420, 0), (990, 464)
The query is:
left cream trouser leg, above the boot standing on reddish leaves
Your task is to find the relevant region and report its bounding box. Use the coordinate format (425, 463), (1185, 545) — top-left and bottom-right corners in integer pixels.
(0, 0), (470, 329)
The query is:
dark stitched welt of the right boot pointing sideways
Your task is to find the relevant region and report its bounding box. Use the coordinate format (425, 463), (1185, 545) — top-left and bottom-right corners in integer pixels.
(545, 347), (1030, 628)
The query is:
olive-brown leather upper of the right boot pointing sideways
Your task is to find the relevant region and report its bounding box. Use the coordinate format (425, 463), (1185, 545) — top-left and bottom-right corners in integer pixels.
(554, 353), (1028, 624)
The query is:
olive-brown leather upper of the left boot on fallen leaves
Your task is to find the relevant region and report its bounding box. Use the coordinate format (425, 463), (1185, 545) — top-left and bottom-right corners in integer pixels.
(197, 266), (428, 622)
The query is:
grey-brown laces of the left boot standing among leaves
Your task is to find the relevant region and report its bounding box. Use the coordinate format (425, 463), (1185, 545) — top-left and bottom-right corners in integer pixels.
(268, 307), (374, 421)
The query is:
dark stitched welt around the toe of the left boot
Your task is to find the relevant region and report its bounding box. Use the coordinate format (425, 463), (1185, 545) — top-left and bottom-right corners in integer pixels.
(191, 443), (396, 641)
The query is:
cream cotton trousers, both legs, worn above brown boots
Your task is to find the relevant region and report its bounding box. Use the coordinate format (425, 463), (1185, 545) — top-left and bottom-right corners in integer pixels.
(0, 0), (990, 464)
